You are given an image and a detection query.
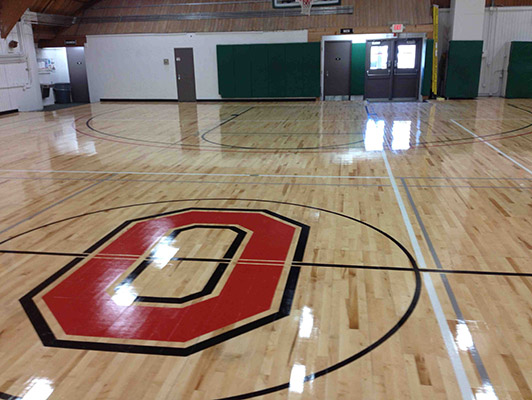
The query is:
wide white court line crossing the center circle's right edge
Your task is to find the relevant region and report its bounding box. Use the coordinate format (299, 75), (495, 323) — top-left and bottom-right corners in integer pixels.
(382, 150), (474, 400)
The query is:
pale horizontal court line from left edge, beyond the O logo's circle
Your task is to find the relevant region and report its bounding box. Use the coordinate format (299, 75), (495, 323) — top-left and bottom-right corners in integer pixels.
(0, 176), (390, 188)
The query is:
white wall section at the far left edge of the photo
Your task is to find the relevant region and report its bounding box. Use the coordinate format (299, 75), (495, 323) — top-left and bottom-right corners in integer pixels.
(0, 22), (42, 112)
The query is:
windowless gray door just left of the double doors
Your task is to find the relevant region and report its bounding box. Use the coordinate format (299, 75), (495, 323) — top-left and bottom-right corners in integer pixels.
(323, 40), (351, 96)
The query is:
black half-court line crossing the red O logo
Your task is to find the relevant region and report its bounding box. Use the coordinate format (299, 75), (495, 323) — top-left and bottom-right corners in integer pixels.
(0, 249), (532, 278)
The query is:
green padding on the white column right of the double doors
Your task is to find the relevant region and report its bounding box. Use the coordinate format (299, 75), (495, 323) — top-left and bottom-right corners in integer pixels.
(445, 40), (482, 99)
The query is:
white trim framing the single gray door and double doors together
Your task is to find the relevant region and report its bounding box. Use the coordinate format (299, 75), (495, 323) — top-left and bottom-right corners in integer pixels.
(320, 33), (431, 101)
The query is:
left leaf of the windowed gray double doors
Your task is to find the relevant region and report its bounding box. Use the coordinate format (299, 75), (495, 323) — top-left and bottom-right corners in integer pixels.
(364, 39), (394, 100)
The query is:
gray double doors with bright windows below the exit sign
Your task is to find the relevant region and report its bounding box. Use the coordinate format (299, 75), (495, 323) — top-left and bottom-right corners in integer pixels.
(364, 39), (423, 100)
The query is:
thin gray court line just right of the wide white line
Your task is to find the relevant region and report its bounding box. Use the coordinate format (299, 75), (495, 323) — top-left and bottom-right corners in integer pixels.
(401, 178), (497, 398)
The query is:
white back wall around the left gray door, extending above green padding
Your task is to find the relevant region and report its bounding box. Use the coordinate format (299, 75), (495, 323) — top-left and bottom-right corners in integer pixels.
(85, 30), (308, 102)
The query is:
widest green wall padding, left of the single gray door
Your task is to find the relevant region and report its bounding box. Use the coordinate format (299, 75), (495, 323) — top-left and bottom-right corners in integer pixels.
(216, 43), (320, 98)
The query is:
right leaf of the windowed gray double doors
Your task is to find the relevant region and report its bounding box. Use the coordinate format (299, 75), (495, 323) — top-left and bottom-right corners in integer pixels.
(392, 39), (422, 99)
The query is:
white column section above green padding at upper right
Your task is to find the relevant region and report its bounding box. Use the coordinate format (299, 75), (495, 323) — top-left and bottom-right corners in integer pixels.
(450, 0), (486, 40)
